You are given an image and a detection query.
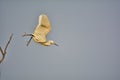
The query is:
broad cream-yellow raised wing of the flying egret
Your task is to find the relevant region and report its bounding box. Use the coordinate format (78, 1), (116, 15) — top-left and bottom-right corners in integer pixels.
(33, 14), (51, 42)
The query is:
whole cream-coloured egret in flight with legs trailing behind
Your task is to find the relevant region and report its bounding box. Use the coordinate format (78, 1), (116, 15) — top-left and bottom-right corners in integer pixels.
(23, 14), (58, 46)
